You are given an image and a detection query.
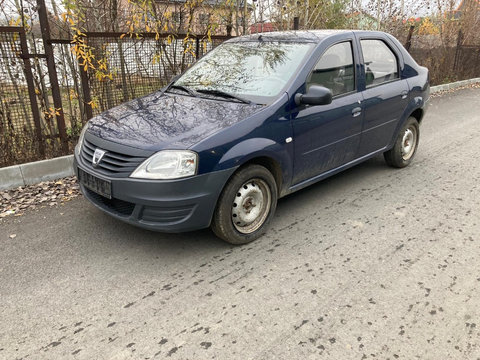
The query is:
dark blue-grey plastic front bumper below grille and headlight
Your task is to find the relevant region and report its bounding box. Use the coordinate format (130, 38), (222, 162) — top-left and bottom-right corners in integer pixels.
(74, 155), (235, 232)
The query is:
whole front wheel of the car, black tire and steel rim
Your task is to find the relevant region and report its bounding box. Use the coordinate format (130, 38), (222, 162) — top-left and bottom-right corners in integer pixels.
(211, 165), (278, 245)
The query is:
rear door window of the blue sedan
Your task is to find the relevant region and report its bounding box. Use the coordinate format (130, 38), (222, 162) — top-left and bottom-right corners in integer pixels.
(360, 40), (399, 86)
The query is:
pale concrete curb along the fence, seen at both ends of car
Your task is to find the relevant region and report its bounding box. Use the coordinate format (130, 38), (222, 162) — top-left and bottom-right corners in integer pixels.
(0, 78), (480, 191)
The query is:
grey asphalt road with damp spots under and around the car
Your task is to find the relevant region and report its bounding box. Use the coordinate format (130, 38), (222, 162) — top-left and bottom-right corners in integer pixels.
(0, 89), (480, 360)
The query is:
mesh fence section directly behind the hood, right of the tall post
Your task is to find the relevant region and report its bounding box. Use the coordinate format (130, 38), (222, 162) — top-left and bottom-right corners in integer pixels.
(75, 33), (229, 118)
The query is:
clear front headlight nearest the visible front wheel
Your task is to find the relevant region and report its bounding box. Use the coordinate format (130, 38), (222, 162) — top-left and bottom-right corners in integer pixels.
(130, 150), (198, 179)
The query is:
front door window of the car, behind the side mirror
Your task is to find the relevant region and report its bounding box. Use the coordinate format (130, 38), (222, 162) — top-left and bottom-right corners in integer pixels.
(307, 41), (355, 96)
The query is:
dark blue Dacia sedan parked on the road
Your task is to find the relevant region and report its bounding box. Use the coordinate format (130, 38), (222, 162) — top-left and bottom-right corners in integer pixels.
(75, 31), (429, 244)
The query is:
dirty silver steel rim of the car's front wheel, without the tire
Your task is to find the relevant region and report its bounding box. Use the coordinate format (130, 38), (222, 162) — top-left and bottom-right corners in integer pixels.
(232, 178), (272, 234)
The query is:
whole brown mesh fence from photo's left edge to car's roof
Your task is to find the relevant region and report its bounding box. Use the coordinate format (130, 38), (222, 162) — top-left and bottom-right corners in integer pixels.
(0, 27), (229, 167)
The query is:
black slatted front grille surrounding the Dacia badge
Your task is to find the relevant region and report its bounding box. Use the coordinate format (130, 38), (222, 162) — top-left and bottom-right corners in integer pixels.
(82, 139), (146, 177)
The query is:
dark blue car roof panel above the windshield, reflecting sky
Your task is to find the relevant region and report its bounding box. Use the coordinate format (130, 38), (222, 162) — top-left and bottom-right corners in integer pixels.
(228, 30), (381, 43)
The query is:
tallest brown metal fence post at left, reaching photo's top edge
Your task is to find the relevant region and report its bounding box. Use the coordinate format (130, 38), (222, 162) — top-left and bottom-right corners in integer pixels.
(37, 0), (68, 154)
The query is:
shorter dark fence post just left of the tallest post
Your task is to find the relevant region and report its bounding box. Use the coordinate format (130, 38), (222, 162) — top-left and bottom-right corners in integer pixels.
(18, 27), (45, 158)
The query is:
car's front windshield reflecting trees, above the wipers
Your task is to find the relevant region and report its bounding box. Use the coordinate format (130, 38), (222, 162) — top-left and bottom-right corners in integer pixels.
(175, 41), (313, 103)
